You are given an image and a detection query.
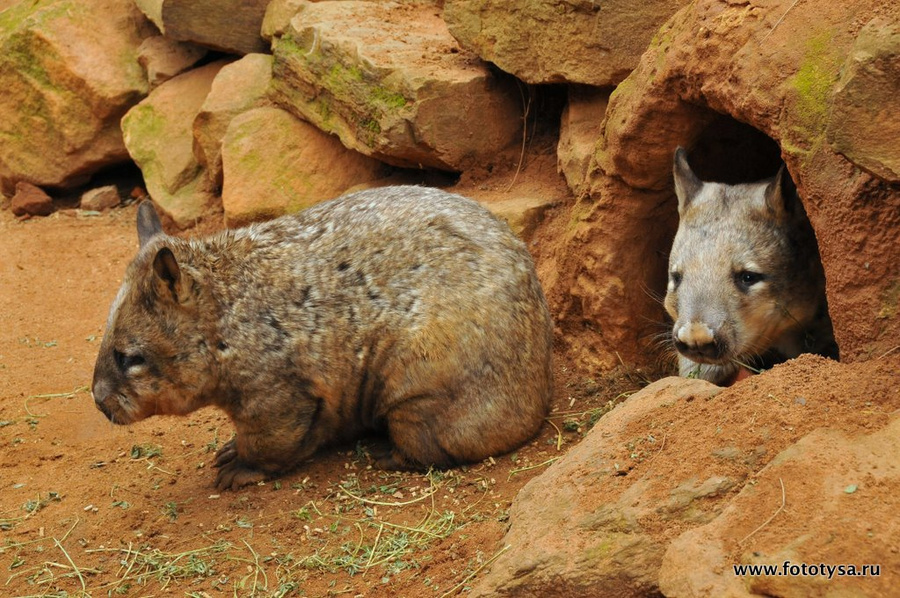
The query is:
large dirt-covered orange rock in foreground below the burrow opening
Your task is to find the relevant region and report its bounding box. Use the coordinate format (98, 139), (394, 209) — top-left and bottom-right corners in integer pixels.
(472, 355), (900, 598)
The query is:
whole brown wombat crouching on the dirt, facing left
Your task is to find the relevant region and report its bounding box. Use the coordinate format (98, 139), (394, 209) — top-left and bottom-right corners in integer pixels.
(92, 187), (553, 489)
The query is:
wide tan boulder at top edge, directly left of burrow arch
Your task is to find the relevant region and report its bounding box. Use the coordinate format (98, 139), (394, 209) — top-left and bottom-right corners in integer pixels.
(444, 0), (687, 87)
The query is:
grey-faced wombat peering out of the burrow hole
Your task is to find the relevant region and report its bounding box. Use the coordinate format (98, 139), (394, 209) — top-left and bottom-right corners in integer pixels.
(665, 147), (838, 385)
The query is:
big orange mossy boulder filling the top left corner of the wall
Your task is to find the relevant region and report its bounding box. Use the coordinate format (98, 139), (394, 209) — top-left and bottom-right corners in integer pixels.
(0, 0), (153, 193)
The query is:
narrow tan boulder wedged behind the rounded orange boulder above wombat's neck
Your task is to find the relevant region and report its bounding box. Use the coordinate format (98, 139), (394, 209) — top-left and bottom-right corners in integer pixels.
(193, 54), (272, 189)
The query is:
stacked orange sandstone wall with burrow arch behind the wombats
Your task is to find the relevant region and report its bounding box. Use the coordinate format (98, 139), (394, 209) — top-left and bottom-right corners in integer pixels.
(0, 0), (900, 368)
